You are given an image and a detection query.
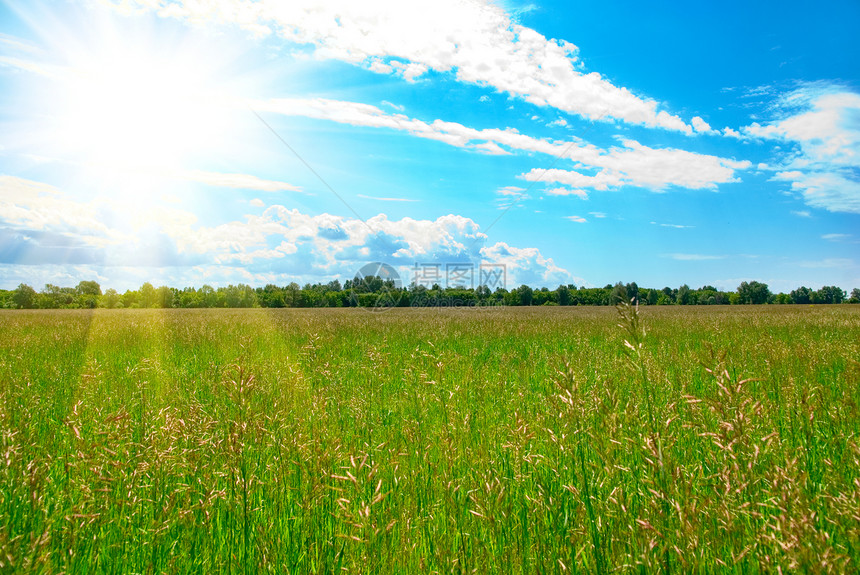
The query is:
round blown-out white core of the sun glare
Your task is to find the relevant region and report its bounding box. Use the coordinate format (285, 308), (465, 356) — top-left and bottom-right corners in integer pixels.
(52, 25), (240, 177)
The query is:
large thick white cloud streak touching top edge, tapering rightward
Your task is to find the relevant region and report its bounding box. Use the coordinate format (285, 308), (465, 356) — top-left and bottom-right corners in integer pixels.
(107, 0), (693, 134)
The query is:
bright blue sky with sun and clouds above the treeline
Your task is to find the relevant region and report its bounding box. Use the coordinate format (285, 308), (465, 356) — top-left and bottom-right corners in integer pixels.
(0, 0), (860, 291)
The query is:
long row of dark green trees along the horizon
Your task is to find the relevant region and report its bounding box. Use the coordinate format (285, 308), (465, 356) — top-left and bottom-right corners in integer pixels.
(0, 276), (860, 309)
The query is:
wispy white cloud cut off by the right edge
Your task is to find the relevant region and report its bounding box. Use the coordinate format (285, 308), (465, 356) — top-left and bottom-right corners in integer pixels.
(743, 88), (860, 213)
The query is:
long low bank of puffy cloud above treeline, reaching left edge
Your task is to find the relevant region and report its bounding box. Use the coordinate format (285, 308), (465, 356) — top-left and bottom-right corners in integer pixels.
(0, 176), (566, 283)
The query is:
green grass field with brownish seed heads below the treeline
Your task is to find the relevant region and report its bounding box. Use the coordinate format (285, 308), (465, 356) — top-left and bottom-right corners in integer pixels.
(0, 305), (860, 573)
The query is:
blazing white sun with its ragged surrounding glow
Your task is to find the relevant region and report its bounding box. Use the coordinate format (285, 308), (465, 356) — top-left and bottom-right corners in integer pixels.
(15, 6), (255, 182)
